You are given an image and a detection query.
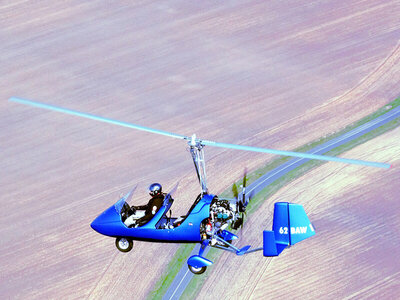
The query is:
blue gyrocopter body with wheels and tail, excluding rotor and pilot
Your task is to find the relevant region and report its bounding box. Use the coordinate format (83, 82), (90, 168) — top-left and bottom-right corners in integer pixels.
(91, 186), (315, 274)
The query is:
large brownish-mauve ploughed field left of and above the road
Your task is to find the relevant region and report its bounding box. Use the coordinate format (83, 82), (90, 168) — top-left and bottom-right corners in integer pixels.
(0, 0), (400, 299)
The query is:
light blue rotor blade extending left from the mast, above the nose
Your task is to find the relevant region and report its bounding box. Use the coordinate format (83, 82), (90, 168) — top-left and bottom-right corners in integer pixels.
(8, 97), (190, 140)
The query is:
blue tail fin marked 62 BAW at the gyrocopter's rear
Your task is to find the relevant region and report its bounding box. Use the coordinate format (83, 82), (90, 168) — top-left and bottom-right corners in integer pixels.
(263, 202), (315, 256)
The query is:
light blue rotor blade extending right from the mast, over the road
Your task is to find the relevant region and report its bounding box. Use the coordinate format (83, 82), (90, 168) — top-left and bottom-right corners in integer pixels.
(201, 140), (391, 169)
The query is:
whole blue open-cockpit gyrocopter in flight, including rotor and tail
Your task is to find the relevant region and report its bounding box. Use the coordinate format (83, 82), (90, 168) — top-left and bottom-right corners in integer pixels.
(9, 97), (390, 274)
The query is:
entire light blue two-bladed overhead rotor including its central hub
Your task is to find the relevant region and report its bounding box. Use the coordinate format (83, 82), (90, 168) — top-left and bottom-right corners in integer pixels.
(9, 97), (391, 169)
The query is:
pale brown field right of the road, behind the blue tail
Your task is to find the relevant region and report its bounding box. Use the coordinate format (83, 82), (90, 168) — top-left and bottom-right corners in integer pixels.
(198, 128), (400, 299)
